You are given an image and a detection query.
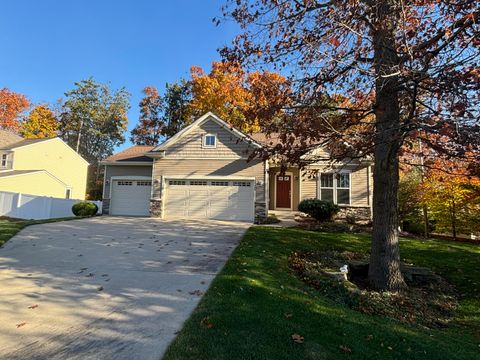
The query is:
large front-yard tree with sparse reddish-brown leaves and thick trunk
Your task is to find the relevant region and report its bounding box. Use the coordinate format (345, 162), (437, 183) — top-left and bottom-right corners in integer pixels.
(221, 0), (480, 290)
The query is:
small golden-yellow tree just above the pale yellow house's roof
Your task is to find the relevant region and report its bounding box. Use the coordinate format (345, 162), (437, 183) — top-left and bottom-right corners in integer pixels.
(20, 104), (59, 139)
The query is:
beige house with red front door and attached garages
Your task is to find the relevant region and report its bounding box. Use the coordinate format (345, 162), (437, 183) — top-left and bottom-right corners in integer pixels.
(102, 113), (372, 222)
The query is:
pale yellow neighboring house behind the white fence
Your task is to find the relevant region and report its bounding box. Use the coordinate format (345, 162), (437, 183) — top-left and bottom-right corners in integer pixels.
(0, 130), (88, 199)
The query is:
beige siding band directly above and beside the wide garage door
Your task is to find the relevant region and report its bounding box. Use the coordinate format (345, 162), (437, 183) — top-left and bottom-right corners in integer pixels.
(153, 158), (266, 202)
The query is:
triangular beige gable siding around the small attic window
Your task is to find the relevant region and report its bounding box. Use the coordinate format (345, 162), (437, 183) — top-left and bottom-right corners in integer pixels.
(165, 120), (253, 158)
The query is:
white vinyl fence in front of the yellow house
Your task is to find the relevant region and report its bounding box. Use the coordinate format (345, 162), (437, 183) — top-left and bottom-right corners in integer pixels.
(0, 191), (102, 220)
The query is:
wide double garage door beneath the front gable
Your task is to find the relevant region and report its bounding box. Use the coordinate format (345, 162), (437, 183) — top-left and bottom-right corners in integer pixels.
(165, 179), (255, 221)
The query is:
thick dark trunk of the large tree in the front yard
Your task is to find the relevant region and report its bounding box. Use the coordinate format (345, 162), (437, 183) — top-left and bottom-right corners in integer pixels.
(368, 0), (406, 291)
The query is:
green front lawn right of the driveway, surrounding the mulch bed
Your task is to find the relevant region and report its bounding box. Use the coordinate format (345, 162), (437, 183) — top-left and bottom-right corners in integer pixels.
(164, 227), (480, 360)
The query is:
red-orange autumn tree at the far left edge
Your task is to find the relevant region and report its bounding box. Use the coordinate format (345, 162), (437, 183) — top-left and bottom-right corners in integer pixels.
(0, 88), (30, 131)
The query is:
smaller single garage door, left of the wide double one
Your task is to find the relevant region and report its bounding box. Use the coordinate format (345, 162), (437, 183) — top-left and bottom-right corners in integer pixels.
(110, 180), (152, 216)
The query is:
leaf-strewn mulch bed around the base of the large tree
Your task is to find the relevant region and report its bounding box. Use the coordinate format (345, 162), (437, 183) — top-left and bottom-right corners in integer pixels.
(289, 251), (458, 328)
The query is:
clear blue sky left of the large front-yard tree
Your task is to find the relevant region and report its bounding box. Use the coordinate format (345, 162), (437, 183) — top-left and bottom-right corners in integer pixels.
(0, 0), (238, 149)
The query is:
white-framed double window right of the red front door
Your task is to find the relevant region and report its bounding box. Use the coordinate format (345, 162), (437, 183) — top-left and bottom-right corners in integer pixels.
(319, 172), (350, 205)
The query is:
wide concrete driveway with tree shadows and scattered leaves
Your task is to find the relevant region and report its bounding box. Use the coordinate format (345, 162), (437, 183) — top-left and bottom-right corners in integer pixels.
(0, 217), (249, 360)
